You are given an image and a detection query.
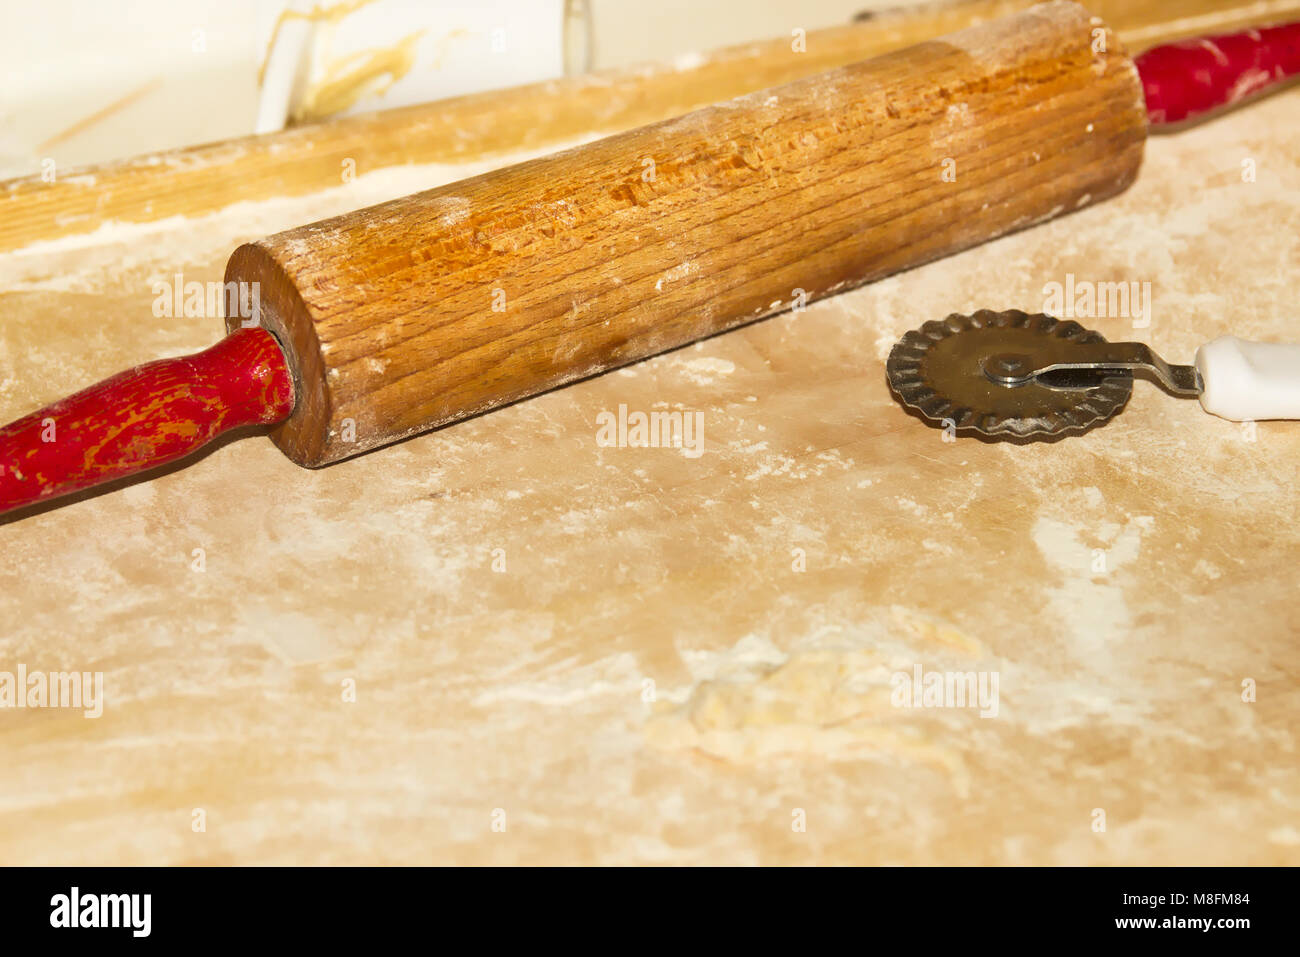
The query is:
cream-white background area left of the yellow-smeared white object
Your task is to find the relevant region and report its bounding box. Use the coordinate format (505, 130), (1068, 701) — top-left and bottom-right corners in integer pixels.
(0, 0), (266, 177)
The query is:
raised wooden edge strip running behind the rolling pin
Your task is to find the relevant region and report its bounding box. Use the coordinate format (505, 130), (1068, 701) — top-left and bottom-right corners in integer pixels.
(0, 0), (1300, 251)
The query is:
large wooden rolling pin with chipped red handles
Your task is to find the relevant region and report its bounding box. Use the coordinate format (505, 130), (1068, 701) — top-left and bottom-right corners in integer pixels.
(0, 3), (1295, 508)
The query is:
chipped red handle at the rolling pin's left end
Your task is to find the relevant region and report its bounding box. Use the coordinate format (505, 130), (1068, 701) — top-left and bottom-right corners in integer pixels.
(0, 329), (294, 512)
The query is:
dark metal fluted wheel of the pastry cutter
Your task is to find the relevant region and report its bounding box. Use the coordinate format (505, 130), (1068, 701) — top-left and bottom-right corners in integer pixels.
(885, 309), (1132, 438)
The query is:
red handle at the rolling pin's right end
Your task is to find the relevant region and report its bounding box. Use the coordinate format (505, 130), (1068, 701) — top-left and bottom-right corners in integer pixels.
(1135, 23), (1300, 126)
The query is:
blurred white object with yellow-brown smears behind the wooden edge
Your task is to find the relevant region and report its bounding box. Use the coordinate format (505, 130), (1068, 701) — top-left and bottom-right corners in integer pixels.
(256, 0), (588, 133)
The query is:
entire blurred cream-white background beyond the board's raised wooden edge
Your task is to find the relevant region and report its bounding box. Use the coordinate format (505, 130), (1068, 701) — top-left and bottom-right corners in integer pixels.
(0, 0), (898, 178)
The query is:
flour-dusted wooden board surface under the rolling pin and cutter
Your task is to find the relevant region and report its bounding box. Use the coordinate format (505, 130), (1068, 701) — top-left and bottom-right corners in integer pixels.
(0, 26), (1300, 865)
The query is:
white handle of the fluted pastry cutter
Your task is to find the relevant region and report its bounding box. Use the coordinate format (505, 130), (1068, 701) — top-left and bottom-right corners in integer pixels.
(1196, 335), (1300, 423)
